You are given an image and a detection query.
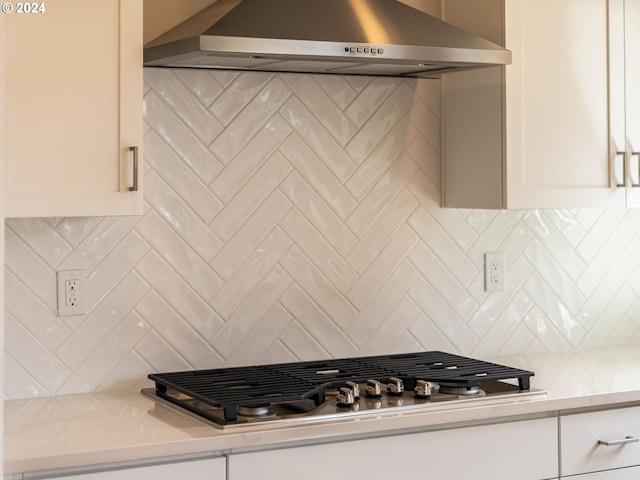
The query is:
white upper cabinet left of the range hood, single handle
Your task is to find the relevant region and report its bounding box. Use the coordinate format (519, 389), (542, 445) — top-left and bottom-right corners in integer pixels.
(3, 0), (143, 217)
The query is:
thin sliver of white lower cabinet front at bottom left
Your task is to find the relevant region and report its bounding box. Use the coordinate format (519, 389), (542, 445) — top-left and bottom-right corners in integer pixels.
(20, 457), (227, 480)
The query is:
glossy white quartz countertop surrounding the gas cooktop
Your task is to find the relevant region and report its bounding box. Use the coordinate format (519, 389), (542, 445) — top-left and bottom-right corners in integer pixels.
(3, 347), (640, 474)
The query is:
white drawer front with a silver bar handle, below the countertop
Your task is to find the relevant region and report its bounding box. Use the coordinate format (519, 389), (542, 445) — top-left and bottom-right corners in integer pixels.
(560, 407), (640, 475)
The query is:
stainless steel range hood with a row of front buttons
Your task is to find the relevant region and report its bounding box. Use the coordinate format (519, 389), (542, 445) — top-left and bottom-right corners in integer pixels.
(144, 0), (511, 77)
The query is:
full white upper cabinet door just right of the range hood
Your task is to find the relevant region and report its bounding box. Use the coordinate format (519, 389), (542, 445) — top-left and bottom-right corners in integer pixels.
(505, 0), (625, 208)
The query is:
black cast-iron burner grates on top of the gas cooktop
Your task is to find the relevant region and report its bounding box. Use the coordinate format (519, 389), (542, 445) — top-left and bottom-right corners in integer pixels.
(149, 351), (533, 422)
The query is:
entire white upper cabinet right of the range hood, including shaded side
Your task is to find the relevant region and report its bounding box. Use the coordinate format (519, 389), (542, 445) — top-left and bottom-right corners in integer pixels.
(442, 0), (640, 209)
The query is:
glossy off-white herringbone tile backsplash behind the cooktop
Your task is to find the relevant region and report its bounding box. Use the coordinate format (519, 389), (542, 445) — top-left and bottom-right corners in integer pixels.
(5, 69), (640, 398)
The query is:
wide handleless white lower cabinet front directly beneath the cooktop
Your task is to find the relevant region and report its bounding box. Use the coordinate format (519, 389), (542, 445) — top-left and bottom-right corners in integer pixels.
(227, 418), (558, 480)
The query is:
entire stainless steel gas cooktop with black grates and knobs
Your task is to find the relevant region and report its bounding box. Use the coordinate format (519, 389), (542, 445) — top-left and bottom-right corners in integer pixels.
(143, 351), (546, 429)
